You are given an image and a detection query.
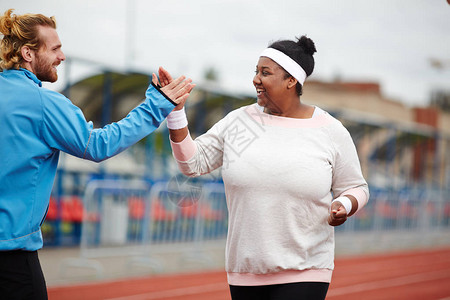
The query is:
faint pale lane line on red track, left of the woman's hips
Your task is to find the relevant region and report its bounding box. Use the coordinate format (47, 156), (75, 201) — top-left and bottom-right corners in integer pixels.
(106, 282), (228, 300)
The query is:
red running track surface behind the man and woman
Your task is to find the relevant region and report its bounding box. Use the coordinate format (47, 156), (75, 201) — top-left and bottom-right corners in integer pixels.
(48, 248), (450, 300)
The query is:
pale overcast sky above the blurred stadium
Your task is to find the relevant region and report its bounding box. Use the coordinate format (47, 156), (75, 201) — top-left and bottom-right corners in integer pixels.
(0, 0), (450, 106)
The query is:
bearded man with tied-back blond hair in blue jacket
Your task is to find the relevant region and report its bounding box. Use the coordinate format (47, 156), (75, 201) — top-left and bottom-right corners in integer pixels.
(0, 9), (194, 300)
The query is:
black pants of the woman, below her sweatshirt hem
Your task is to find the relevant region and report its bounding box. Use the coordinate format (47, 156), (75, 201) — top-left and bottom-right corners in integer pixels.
(230, 282), (330, 300)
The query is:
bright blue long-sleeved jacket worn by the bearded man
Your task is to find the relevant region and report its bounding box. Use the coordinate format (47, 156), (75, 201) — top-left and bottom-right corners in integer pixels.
(0, 69), (175, 251)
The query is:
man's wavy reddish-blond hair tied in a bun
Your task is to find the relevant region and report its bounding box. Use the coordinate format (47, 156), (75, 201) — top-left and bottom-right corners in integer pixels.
(0, 8), (56, 70)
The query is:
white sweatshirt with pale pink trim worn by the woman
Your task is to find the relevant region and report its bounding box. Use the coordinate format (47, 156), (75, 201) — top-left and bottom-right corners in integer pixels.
(172, 104), (369, 285)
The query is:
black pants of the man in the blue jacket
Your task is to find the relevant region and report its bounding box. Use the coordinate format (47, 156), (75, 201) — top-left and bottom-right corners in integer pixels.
(0, 250), (47, 300)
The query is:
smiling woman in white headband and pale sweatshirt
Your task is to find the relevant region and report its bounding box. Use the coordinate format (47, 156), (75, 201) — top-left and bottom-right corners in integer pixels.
(160, 36), (369, 300)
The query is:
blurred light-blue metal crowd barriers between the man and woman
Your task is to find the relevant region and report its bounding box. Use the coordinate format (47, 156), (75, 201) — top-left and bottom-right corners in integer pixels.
(61, 175), (228, 277)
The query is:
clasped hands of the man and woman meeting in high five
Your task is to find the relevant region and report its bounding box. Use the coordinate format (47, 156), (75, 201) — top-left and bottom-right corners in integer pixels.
(152, 67), (195, 110)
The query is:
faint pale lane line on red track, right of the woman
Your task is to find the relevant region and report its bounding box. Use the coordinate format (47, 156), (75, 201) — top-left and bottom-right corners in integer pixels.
(327, 269), (450, 297)
